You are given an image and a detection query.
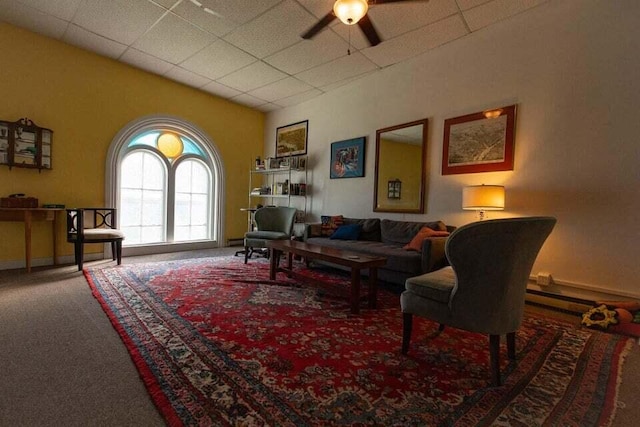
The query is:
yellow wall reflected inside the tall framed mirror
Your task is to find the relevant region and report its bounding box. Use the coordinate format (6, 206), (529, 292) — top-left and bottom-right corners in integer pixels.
(378, 139), (422, 209)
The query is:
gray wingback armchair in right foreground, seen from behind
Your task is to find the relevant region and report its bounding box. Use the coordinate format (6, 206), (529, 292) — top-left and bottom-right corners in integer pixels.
(400, 217), (556, 386)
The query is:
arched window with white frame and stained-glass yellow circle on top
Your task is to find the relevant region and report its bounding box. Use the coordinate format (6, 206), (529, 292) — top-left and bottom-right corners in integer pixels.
(107, 116), (224, 255)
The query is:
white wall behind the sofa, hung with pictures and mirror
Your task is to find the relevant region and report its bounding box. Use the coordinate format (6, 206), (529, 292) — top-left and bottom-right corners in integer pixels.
(265, 0), (640, 296)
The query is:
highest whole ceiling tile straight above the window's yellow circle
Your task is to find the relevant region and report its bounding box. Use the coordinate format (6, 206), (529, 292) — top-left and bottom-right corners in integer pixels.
(133, 13), (216, 64)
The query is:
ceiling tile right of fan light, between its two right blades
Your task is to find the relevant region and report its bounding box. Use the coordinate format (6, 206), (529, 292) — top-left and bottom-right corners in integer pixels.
(368, 0), (458, 40)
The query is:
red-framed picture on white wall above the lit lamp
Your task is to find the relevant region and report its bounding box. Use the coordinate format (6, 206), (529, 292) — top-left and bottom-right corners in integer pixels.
(442, 105), (516, 175)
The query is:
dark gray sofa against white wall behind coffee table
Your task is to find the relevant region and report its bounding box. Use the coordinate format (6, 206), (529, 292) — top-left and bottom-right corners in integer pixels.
(304, 218), (455, 285)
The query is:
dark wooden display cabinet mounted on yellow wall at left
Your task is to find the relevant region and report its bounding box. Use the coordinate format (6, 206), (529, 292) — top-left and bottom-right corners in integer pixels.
(0, 117), (53, 170)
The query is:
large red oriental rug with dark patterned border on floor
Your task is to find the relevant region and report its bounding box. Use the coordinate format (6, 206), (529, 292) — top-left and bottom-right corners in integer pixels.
(85, 257), (632, 426)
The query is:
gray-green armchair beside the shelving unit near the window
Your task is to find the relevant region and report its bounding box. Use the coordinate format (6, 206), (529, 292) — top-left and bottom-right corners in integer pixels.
(244, 206), (296, 264)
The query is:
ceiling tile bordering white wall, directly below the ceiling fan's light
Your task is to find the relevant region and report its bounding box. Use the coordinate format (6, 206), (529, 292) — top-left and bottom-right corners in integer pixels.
(296, 52), (376, 87)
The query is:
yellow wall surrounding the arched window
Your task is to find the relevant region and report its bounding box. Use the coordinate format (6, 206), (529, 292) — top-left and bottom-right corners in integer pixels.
(0, 23), (264, 268)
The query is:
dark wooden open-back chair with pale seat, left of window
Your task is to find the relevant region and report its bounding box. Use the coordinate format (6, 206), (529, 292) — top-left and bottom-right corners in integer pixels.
(67, 208), (124, 271)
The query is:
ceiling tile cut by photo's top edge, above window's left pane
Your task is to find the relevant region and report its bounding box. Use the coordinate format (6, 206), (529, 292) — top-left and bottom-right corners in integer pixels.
(72, 0), (166, 45)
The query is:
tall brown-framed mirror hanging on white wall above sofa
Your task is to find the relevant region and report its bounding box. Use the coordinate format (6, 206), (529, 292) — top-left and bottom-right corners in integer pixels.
(373, 119), (428, 213)
